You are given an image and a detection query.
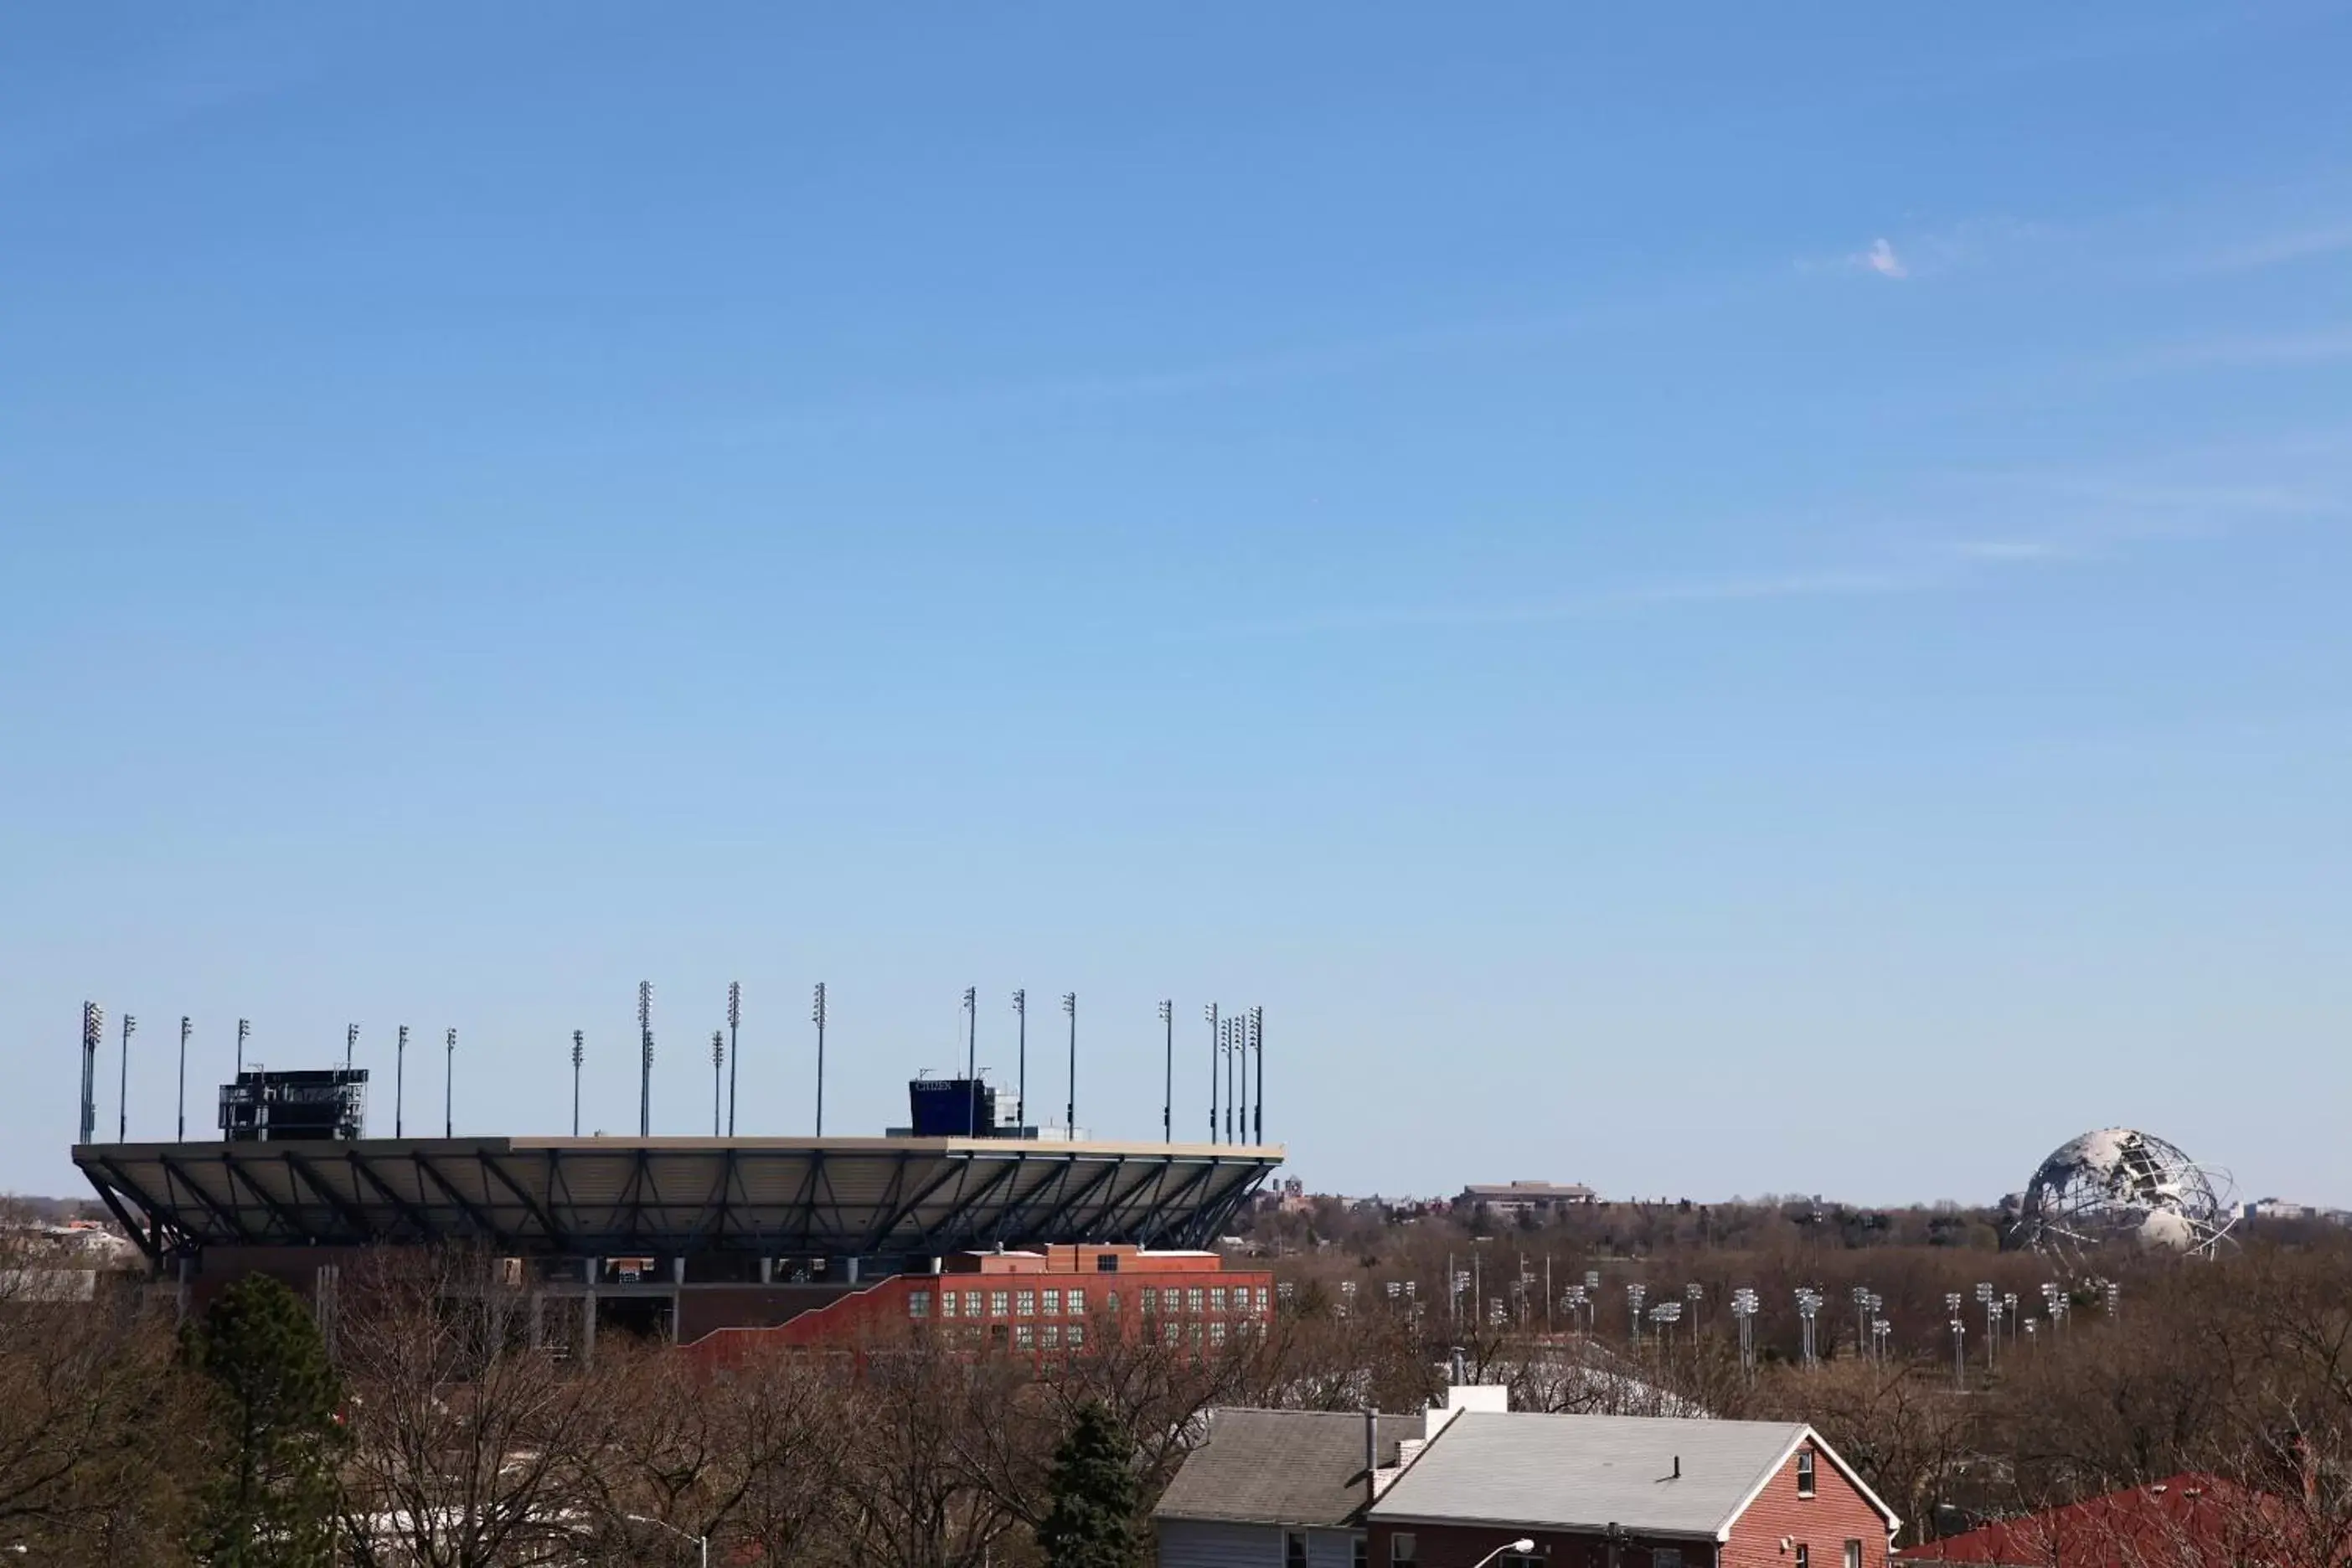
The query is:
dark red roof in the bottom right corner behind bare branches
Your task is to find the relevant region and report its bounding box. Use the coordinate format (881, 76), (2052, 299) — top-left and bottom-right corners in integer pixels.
(1896, 1474), (2293, 1568)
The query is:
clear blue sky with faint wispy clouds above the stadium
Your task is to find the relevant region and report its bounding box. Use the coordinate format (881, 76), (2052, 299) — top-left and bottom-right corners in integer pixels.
(0, 0), (2352, 1204)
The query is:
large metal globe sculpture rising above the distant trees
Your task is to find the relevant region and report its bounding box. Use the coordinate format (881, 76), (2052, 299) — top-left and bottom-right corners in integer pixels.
(2015, 1126), (2232, 1265)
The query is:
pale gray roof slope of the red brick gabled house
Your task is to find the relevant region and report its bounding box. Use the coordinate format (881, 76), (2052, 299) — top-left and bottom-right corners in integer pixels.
(1371, 1411), (1807, 1538)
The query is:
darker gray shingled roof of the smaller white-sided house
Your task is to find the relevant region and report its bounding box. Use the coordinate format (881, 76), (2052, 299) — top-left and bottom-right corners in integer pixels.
(1153, 1411), (1421, 1525)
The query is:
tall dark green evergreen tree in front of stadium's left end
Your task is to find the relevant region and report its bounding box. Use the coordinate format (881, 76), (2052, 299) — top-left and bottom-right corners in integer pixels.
(190, 1274), (341, 1568)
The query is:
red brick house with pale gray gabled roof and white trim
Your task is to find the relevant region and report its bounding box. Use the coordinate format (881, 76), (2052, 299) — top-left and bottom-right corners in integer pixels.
(1366, 1413), (1901, 1568)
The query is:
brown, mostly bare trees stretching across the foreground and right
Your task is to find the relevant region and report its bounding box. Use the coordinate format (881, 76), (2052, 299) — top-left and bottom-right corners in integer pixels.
(0, 1234), (2352, 1568)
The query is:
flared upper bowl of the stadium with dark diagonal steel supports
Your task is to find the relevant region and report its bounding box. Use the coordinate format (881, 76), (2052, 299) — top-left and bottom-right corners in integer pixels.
(73, 1137), (1282, 1258)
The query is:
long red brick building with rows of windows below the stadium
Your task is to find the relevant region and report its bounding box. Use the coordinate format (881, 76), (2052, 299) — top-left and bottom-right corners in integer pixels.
(692, 1244), (1275, 1359)
